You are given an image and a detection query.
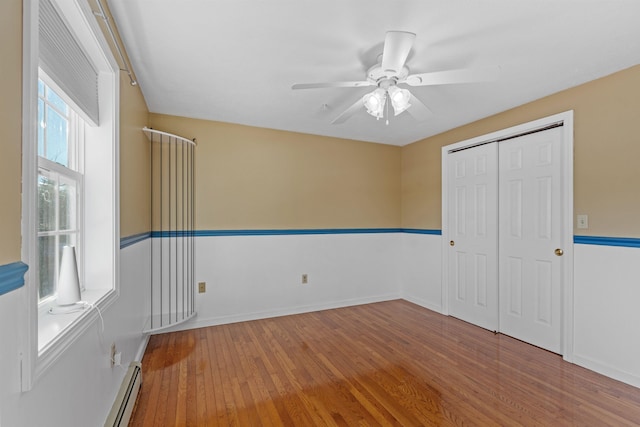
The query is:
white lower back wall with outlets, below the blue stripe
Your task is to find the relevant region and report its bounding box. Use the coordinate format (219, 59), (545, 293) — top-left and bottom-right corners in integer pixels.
(172, 233), (402, 329)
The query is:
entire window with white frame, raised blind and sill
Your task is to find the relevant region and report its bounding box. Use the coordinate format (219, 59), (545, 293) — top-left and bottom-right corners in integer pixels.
(21, 0), (120, 391)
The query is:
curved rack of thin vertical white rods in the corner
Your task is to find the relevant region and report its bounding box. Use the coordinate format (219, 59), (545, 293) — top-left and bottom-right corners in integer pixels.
(144, 128), (196, 333)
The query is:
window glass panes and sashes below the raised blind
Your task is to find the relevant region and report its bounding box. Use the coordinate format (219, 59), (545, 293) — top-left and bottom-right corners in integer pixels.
(37, 79), (84, 303)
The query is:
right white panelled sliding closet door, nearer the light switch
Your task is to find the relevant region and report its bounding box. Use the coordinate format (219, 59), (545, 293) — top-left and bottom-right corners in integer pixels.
(498, 127), (564, 353)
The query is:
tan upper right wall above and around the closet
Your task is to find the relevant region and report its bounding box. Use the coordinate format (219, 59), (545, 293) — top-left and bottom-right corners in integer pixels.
(402, 66), (640, 237)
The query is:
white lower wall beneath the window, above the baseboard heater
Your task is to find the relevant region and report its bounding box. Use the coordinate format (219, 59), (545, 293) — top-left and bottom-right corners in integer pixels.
(0, 239), (150, 427)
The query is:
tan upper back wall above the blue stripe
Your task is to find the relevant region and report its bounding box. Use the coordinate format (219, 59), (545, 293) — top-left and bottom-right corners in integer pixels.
(149, 114), (401, 230)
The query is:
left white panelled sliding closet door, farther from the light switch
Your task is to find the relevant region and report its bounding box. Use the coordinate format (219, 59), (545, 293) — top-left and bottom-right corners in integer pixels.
(448, 143), (498, 331)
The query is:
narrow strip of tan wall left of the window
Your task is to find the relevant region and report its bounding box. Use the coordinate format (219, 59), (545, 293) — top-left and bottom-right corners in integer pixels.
(0, 0), (22, 265)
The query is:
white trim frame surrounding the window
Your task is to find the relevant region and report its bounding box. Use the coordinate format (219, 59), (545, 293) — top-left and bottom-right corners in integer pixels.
(21, 0), (120, 391)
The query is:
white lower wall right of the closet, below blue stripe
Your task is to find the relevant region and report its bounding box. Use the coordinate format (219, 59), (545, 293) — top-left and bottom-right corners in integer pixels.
(574, 244), (640, 387)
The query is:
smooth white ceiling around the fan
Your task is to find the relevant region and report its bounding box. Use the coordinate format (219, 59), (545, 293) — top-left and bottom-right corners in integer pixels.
(108, 0), (640, 145)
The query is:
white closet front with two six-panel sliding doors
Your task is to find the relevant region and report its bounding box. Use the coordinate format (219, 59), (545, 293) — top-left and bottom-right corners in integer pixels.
(443, 113), (573, 353)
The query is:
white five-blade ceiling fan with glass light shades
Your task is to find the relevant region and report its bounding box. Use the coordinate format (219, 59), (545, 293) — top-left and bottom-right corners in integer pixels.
(291, 31), (498, 124)
